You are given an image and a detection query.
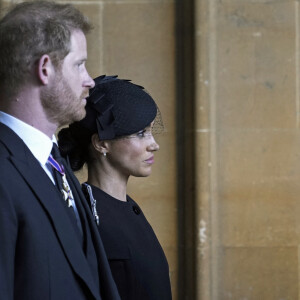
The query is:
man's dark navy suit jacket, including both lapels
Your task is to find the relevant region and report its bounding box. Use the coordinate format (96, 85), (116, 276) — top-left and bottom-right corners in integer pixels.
(0, 123), (120, 300)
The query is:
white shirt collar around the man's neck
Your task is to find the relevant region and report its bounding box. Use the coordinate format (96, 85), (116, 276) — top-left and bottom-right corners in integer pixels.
(0, 111), (57, 165)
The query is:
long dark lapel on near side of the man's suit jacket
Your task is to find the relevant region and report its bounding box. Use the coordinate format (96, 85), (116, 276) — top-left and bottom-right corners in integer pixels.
(0, 124), (99, 299)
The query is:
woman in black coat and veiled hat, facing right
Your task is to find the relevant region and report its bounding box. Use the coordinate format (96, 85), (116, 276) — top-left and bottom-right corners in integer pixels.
(58, 76), (172, 300)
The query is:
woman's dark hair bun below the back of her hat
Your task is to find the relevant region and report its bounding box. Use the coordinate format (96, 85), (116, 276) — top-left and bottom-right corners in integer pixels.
(58, 123), (93, 171)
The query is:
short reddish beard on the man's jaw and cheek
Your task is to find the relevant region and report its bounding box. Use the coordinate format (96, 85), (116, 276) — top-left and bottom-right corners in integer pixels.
(41, 72), (88, 127)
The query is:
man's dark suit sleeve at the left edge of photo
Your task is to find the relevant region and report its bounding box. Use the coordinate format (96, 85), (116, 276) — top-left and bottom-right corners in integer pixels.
(0, 182), (18, 300)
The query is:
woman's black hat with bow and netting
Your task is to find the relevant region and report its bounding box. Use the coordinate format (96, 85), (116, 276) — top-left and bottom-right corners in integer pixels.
(78, 75), (158, 140)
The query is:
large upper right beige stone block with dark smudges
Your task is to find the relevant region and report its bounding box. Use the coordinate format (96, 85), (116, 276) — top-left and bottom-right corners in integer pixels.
(216, 1), (296, 128)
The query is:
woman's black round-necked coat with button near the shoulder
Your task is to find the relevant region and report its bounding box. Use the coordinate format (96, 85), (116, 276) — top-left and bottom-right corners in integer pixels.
(88, 186), (172, 300)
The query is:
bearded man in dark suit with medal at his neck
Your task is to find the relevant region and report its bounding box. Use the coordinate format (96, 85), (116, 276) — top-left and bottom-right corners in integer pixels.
(0, 1), (120, 300)
